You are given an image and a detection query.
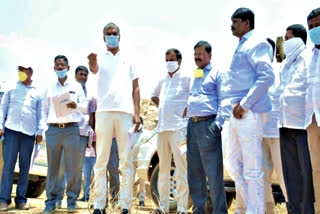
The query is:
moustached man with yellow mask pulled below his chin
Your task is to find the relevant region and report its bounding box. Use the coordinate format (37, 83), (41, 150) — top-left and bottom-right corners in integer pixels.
(187, 41), (228, 214)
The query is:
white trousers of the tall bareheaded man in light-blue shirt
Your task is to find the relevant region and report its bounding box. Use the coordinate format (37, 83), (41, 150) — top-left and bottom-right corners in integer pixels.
(225, 110), (265, 214)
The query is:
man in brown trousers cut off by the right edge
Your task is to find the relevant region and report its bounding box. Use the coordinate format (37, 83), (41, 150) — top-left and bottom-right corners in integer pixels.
(305, 8), (320, 214)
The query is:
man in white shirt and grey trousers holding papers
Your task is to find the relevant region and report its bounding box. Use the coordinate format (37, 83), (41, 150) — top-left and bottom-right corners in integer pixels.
(41, 55), (87, 213)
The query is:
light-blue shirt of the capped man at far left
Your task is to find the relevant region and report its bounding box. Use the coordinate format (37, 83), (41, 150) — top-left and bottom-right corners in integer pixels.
(0, 82), (42, 136)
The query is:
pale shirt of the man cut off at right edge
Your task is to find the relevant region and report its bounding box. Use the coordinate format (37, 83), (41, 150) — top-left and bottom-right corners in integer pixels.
(305, 47), (320, 128)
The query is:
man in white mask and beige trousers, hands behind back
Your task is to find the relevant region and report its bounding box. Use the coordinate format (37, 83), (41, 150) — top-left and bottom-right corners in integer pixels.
(151, 48), (191, 214)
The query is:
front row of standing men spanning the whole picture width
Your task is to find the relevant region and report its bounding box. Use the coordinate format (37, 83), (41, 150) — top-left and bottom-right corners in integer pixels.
(0, 5), (320, 214)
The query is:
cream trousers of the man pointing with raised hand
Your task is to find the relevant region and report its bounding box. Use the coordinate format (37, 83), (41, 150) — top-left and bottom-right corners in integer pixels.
(94, 112), (133, 209)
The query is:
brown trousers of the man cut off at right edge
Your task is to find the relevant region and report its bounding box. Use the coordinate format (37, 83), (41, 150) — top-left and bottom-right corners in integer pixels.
(307, 114), (320, 214)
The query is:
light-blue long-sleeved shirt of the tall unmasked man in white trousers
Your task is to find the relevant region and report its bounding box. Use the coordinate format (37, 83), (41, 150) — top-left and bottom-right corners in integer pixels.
(223, 31), (274, 113)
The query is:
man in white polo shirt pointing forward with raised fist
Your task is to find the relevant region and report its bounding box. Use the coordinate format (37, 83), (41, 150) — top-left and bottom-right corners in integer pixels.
(88, 22), (140, 214)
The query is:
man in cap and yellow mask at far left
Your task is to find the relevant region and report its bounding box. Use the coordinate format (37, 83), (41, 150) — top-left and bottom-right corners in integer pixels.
(0, 66), (42, 211)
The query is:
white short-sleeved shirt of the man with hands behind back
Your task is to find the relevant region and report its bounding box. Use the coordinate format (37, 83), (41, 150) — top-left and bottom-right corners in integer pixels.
(151, 69), (191, 132)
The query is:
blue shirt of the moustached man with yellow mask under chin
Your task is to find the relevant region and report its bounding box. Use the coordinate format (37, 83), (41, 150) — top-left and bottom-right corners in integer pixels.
(187, 63), (224, 128)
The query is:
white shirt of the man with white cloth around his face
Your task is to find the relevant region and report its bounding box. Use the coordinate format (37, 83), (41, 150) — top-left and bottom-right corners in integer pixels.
(278, 44), (307, 129)
